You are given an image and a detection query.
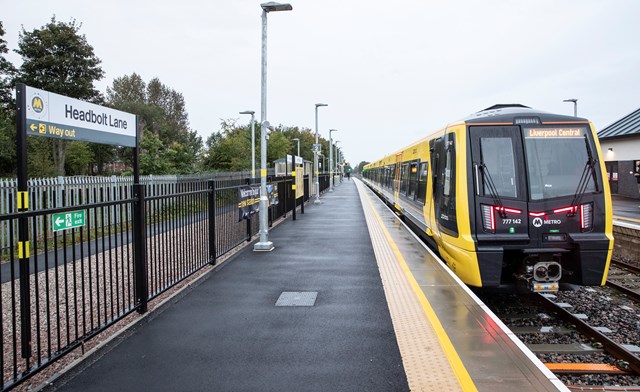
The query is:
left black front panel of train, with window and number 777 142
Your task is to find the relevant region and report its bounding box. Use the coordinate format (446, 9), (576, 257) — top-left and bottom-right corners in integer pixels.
(469, 126), (529, 240)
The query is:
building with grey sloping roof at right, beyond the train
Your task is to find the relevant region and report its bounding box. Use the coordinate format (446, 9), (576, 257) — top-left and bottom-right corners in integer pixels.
(598, 109), (640, 198)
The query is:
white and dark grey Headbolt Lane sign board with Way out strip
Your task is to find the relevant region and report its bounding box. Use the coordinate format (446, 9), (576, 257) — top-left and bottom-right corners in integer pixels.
(25, 86), (136, 147)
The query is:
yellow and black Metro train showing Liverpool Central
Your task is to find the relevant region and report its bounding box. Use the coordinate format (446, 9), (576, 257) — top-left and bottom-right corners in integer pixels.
(362, 104), (613, 292)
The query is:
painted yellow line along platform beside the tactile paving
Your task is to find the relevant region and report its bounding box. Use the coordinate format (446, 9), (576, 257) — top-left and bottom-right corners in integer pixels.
(363, 188), (478, 391)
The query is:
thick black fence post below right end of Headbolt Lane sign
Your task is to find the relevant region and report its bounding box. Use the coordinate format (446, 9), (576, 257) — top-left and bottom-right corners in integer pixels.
(133, 184), (149, 313)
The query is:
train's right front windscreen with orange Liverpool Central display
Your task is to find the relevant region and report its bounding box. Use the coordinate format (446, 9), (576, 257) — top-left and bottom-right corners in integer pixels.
(522, 126), (596, 200)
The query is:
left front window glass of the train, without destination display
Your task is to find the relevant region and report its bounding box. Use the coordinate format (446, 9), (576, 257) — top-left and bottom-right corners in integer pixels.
(480, 137), (518, 198)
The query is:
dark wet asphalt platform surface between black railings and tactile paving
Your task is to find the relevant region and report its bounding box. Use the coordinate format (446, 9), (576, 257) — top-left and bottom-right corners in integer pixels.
(54, 181), (408, 392)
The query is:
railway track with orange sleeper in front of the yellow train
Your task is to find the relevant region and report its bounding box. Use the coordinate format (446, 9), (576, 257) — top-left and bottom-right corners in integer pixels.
(483, 288), (640, 390)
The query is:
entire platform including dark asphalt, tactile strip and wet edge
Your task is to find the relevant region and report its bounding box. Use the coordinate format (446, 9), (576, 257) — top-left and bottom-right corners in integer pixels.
(48, 180), (566, 391)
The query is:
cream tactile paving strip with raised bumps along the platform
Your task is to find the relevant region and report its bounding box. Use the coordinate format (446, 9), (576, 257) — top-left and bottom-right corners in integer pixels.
(356, 181), (462, 391)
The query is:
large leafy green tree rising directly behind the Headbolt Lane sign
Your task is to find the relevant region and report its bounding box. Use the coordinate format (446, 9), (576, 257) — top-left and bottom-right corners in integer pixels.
(15, 16), (104, 175)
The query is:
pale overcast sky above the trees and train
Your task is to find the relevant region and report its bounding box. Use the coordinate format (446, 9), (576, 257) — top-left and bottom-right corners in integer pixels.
(5, 0), (640, 165)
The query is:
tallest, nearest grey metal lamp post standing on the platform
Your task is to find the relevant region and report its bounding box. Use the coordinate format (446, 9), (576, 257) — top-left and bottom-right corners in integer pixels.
(253, 1), (293, 251)
